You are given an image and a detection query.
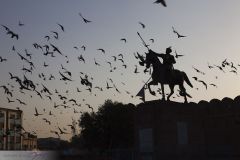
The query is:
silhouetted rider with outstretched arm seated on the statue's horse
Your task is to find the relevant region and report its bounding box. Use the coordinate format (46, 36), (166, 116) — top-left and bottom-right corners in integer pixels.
(149, 47), (176, 80)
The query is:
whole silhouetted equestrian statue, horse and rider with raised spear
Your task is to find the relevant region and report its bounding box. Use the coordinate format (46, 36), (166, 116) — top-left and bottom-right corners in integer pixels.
(137, 32), (193, 103)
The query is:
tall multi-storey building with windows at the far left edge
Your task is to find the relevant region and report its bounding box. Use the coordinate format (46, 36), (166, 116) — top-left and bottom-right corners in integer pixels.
(0, 108), (22, 150)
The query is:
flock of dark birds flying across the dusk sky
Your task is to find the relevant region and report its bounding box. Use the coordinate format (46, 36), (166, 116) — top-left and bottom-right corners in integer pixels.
(0, 0), (240, 138)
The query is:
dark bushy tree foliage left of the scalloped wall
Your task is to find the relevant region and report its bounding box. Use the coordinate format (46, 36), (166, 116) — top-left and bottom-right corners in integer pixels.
(78, 100), (135, 149)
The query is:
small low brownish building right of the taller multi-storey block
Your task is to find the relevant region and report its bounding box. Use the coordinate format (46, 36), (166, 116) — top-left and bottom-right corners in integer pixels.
(22, 132), (37, 150)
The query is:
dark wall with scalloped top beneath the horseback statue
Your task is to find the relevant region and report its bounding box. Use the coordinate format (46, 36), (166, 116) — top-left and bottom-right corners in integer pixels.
(135, 96), (240, 160)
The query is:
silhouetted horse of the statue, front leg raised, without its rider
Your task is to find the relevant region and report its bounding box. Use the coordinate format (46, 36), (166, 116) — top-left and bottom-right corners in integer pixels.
(144, 50), (193, 103)
